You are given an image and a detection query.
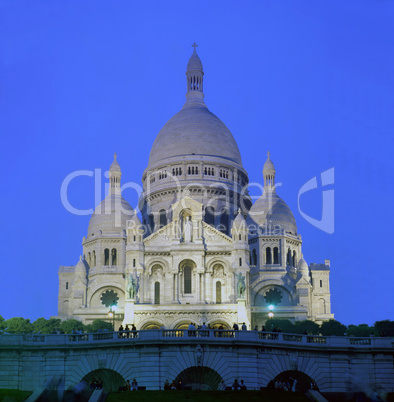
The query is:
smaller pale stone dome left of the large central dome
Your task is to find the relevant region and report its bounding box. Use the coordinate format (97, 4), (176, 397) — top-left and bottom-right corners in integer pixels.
(88, 193), (134, 236)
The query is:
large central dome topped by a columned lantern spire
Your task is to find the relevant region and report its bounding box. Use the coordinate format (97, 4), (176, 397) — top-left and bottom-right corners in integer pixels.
(148, 46), (242, 170)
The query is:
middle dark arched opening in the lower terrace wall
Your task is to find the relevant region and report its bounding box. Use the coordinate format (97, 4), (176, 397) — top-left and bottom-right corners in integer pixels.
(175, 366), (222, 391)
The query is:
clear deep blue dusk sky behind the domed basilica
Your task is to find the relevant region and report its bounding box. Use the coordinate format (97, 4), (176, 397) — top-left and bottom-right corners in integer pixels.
(0, 0), (394, 324)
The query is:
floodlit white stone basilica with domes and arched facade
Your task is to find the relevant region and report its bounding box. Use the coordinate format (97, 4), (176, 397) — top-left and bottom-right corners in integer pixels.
(58, 47), (333, 329)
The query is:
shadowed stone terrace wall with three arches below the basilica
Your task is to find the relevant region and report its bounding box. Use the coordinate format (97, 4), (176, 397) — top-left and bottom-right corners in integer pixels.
(0, 330), (394, 393)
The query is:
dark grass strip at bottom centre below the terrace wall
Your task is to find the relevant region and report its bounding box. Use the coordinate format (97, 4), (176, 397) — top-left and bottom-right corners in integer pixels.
(106, 391), (309, 402)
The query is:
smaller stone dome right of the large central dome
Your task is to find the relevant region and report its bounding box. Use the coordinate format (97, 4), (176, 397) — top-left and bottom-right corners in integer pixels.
(248, 190), (297, 235)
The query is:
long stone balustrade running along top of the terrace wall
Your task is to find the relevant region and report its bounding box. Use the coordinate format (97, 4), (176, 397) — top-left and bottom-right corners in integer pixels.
(0, 329), (394, 348)
